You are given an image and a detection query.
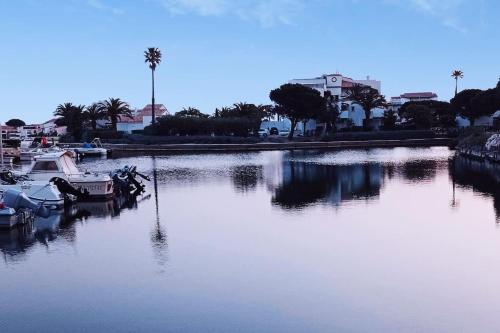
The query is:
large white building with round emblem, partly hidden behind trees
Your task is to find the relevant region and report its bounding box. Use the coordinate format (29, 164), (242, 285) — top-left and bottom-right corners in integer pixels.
(289, 73), (384, 131)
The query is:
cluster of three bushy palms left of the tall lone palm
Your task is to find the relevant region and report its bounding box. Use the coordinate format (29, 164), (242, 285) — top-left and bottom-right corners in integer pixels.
(54, 98), (132, 139)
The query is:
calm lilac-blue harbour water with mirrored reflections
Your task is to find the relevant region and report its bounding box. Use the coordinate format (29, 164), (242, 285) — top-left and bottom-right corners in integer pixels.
(0, 148), (500, 332)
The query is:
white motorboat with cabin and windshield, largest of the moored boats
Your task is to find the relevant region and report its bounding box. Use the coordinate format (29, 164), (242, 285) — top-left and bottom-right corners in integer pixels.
(26, 151), (114, 199)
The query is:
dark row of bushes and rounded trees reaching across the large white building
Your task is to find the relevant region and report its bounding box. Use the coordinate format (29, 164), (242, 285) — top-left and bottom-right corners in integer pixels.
(146, 84), (386, 138)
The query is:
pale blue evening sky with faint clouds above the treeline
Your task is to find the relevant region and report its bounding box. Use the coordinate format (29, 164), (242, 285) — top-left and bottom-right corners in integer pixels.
(0, 0), (500, 122)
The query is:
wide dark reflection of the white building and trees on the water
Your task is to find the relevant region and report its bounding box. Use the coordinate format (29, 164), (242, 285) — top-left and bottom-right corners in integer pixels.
(230, 151), (447, 210)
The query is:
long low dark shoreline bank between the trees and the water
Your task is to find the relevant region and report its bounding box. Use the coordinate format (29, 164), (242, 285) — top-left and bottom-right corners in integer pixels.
(98, 138), (456, 156)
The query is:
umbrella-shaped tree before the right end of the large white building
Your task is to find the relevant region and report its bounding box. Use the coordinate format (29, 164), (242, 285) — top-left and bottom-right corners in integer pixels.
(344, 84), (387, 130)
